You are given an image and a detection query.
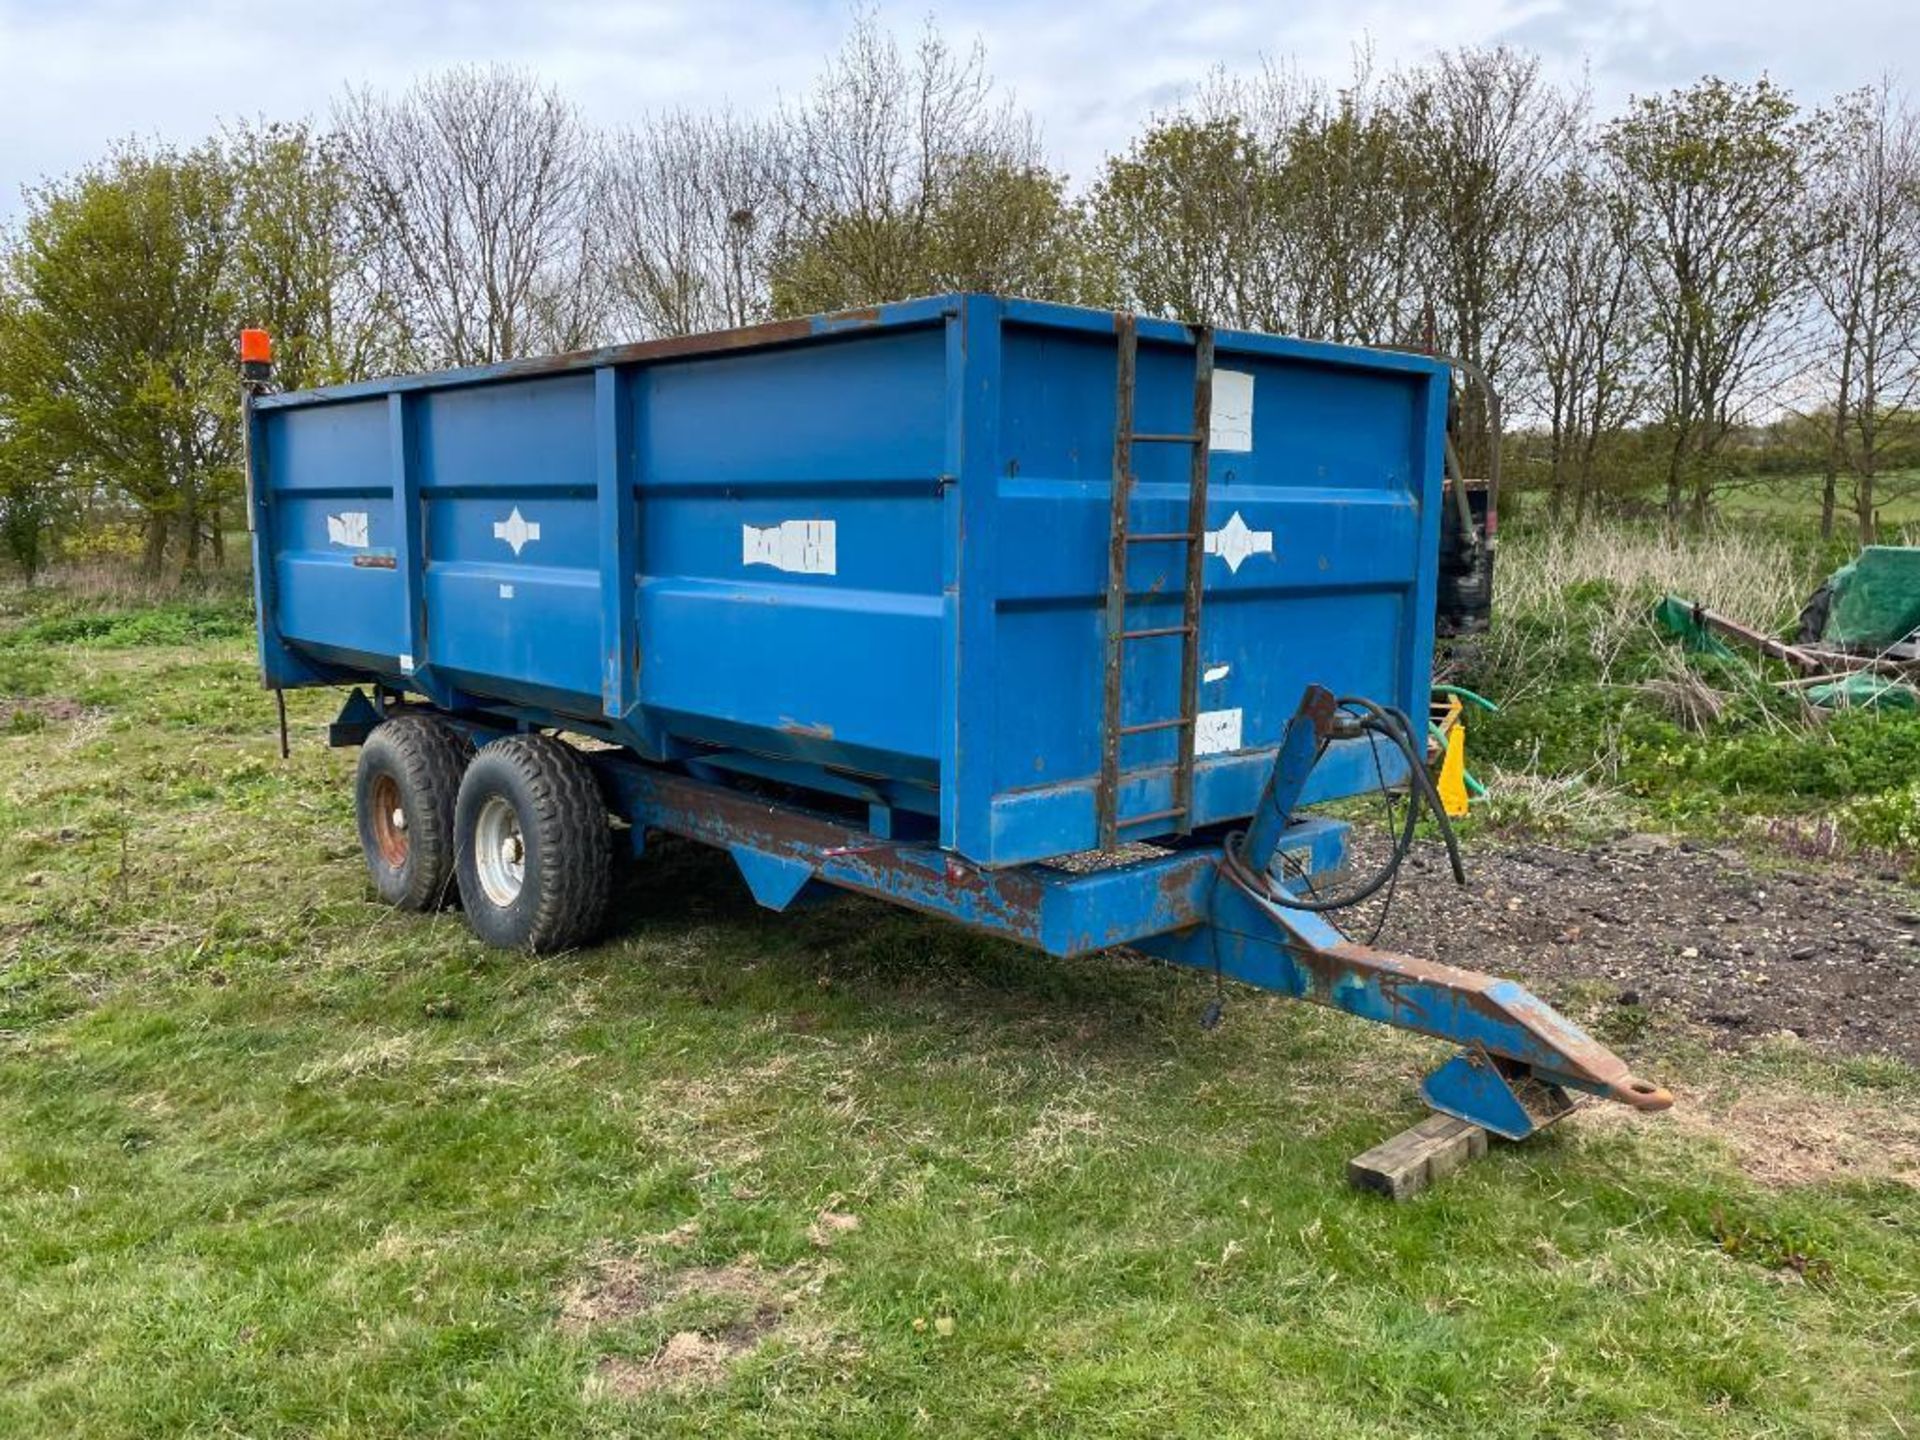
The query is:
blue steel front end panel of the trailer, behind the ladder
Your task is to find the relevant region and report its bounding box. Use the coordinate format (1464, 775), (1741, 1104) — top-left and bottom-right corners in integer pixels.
(962, 303), (1446, 864)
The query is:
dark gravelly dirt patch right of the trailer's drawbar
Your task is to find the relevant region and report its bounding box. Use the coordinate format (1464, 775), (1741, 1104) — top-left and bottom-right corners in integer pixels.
(1342, 835), (1920, 1064)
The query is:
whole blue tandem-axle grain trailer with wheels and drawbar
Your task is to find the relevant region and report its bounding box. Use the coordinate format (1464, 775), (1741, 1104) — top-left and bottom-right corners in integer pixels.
(246, 296), (1670, 1137)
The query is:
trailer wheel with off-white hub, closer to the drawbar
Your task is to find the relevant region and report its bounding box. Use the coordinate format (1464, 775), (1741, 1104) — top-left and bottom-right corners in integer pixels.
(453, 735), (612, 950)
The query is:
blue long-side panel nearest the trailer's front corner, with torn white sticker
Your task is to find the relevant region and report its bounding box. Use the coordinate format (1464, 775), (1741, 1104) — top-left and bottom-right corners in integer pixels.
(634, 324), (948, 780)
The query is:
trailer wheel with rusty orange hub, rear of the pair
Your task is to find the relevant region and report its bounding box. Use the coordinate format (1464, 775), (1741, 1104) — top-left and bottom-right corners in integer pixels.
(353, 714), (474, 910)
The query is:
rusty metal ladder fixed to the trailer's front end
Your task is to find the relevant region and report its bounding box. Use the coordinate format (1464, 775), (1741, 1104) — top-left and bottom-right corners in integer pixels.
(1096, 315), (1213, 851)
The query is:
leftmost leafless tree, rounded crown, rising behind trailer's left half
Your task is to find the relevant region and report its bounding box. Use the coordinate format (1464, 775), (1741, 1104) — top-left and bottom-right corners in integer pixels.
(336, 65), (605, 365)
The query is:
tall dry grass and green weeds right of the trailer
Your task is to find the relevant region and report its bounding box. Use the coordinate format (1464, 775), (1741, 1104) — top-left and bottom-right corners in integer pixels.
(1463, 528), (1920, 864)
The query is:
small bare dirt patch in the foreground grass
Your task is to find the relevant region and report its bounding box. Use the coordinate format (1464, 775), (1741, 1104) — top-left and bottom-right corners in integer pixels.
(559, 1251), (818, 1398)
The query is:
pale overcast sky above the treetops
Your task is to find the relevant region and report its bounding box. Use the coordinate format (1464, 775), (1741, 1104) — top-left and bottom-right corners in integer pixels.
(0, 0), (1920, 219)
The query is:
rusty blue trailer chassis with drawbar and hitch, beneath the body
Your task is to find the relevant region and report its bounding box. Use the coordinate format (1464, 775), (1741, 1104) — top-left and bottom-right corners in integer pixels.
(330, 687), (1672, 1140)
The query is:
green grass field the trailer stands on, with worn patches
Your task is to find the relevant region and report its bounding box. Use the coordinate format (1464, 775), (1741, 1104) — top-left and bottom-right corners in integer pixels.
(0, 564), (1920, 1438)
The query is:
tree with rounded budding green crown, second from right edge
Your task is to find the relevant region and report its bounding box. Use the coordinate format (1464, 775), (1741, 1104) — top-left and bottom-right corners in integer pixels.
(1601, 77), (1809, 524)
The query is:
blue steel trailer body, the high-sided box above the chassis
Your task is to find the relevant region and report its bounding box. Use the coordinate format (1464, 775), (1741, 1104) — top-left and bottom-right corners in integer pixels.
(253, 296), (1448, 866)
